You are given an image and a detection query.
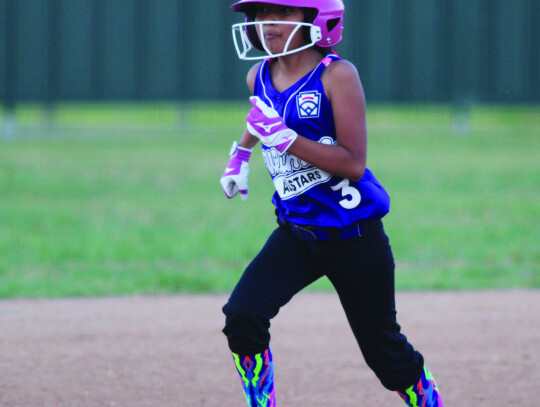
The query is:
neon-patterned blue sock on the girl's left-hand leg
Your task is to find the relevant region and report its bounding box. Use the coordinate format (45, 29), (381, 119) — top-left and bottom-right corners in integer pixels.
(233, 349), (276, 407)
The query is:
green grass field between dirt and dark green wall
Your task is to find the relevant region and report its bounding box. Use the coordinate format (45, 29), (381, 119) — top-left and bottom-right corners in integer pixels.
(0, 102), (540, 298)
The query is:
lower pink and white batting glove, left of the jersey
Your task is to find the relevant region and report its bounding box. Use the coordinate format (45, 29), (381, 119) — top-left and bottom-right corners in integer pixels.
(219, 141), (251, 201)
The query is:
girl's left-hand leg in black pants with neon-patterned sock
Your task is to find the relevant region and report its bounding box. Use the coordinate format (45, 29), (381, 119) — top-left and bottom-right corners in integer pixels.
(223, 227), (321, 407)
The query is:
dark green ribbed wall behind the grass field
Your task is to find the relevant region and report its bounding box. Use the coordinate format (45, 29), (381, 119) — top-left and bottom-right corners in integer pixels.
(0, 0), (540, 104)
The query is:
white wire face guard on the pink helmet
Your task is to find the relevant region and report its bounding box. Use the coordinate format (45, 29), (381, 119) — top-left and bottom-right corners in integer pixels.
(232, 21), (322, 61)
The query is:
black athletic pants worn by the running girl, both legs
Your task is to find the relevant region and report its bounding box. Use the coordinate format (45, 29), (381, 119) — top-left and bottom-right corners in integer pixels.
(223, 221), (424, 390)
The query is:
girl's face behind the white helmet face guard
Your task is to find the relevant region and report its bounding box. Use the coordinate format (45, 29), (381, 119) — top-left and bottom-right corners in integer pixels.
(255, 3), (305, 54)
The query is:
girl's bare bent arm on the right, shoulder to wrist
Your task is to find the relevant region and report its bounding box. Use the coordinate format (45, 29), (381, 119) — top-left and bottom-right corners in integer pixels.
(288, 60), (367, 181)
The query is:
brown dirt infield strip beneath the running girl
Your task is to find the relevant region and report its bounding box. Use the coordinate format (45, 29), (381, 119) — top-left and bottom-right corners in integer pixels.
(0, 290), (540, 407)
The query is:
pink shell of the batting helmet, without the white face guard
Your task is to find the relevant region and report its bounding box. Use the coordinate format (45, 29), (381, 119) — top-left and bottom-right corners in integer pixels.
(231, 0), (345, 47)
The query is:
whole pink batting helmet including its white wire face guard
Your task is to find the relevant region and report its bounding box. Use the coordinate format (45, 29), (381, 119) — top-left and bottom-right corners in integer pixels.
(231, 0), (344, 60)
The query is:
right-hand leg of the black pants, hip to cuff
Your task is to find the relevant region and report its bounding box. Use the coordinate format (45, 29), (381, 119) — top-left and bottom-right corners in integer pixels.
(320, 222), (442, 407)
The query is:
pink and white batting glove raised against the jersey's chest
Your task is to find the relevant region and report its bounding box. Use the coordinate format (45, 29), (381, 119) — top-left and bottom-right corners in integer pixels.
(246, 96), (298, 154)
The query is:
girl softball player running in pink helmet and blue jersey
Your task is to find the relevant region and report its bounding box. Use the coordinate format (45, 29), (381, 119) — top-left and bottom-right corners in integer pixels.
(221, 0), (443, 407)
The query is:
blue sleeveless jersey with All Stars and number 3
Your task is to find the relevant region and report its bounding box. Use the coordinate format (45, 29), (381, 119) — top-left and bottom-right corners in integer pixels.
(254, 55), (390, 227)
